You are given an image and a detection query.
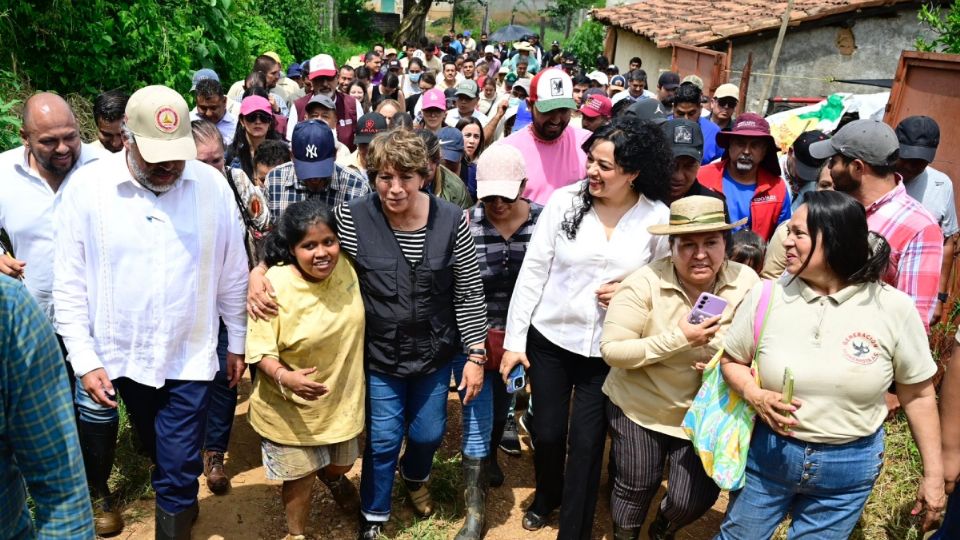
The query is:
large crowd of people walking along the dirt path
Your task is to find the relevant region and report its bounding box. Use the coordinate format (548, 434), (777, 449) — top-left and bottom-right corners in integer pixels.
(0, 28), (960, 540)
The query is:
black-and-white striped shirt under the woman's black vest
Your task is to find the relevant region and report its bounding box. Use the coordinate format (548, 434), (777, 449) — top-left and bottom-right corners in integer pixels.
(334, 200), (487, 347)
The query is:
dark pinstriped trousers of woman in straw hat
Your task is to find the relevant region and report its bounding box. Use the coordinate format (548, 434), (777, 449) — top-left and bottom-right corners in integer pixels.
(607, 403), (720, 531)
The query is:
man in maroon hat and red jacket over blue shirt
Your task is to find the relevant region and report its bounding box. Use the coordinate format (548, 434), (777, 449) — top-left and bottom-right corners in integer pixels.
(697, 113), (791, 241)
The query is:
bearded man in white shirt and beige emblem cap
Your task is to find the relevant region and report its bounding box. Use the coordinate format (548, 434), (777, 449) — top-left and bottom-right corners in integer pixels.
(53, 86), (247, 539)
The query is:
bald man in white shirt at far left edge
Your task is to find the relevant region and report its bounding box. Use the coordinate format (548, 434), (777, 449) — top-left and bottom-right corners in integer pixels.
(0, 93), (123, 534)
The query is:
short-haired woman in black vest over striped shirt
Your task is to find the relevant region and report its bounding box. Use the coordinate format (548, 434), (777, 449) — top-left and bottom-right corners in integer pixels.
(247, 130), (487, 540)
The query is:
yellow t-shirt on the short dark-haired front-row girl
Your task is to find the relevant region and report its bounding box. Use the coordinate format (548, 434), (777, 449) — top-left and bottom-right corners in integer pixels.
(246, 256), (366, 446)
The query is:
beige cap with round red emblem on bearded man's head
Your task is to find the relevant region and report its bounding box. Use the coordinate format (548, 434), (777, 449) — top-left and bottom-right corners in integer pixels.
(126, 85), (197, 163)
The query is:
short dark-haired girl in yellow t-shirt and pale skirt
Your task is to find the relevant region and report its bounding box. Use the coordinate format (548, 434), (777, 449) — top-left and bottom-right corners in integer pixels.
(247, 199), (365, 540)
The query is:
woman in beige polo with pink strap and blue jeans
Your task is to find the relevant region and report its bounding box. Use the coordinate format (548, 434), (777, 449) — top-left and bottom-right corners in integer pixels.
(717, 191), (945, 540)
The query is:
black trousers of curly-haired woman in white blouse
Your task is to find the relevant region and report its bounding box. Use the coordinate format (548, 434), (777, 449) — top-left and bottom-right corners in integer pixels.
(527, 328), (610, 540)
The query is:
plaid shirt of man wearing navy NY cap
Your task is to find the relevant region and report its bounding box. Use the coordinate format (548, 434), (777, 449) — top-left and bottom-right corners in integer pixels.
(264, 161), (370, 225)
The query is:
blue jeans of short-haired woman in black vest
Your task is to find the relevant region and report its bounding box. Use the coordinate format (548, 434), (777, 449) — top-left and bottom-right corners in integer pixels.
(360, 363), (450, 522)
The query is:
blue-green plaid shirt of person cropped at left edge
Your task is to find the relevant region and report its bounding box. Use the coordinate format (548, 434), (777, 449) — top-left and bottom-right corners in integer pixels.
(0, 275), (93, 538)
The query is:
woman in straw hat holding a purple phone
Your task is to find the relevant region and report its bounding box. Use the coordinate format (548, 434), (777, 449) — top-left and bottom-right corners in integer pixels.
(600, 195), (759, 540)
